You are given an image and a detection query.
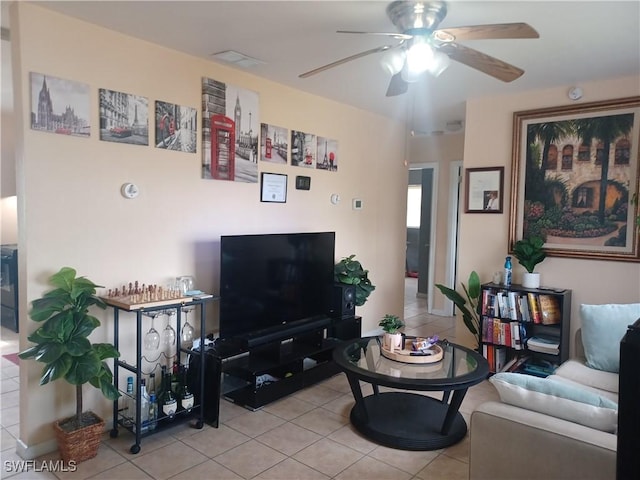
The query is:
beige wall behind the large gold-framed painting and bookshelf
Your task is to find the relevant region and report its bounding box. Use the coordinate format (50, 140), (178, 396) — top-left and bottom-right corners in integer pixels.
(457, 76), (640, 350)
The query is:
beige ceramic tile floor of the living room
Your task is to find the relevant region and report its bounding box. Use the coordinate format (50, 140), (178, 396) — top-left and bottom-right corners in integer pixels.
(0, 279), (497, 480)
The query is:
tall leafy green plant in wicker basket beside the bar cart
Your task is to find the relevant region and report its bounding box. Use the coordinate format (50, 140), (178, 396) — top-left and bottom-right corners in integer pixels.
(19, 267), (120, 462)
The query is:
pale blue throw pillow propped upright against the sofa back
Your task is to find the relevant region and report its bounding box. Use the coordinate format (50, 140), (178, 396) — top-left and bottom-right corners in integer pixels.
(580, 303), (640, 373)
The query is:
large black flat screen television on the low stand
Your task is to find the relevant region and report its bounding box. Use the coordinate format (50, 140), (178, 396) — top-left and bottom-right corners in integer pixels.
(220, 232), (335, 347)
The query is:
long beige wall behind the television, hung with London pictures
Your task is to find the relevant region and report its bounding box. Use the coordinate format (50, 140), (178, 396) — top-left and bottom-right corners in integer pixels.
(11, 4), (407, 454)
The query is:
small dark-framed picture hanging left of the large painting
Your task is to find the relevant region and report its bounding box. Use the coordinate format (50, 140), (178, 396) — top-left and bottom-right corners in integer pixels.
(464, 167), (504, 213)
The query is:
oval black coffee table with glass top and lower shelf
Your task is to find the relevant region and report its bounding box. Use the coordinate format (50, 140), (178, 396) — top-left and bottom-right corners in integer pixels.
(333, 337), (489, 450)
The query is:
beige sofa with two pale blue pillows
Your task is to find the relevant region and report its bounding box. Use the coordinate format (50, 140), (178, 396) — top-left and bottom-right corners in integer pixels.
(469, 304), (640, 480)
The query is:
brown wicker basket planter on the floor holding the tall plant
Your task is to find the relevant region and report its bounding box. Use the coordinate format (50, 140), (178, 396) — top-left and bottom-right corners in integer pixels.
(53, 412), (105, 463)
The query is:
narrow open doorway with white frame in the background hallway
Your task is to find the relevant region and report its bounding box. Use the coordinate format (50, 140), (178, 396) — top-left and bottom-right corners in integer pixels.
(405, 163), (438, 312)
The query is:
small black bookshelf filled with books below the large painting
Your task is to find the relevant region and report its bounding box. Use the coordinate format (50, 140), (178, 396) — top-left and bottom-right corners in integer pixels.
(479, 283), (571, 377)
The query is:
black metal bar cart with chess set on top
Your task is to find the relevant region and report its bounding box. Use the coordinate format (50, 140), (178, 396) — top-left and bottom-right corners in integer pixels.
(102, 294), (219, 454)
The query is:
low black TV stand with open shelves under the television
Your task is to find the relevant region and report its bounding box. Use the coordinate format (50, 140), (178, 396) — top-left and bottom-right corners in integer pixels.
(190, 316), (362, 426)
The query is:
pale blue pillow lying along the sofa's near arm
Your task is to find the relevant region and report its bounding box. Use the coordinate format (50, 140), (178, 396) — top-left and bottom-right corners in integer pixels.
(490, 372), (618, 433)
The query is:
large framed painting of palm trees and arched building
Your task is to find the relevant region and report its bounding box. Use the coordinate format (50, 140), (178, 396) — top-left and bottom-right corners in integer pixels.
(509, 97), (640, 262)
